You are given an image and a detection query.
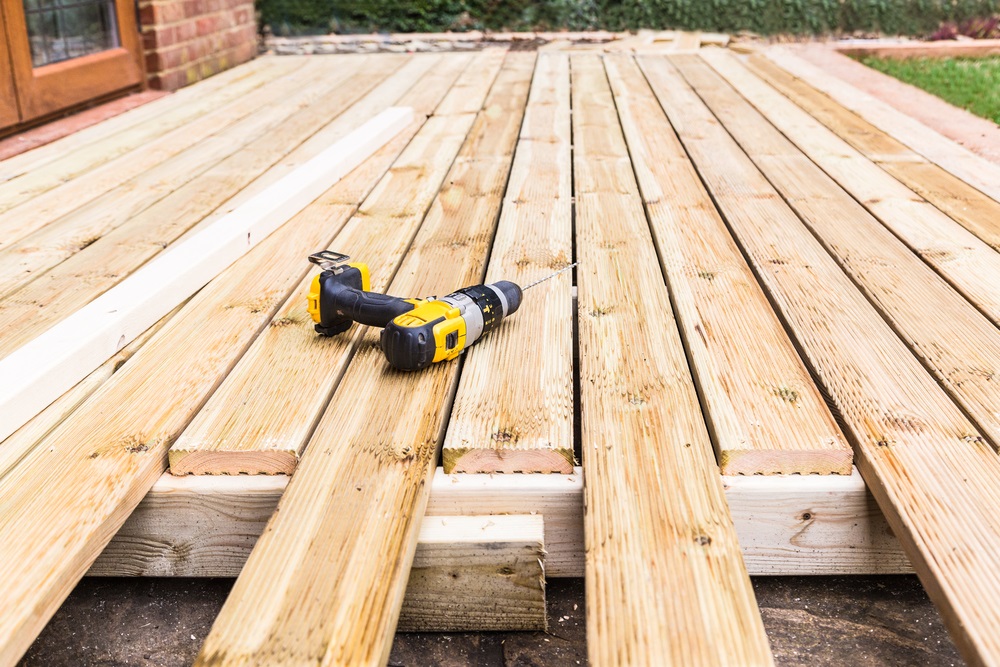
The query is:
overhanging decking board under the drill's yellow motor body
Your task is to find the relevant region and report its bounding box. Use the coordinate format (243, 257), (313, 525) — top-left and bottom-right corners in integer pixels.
(196, 54), (534, 665)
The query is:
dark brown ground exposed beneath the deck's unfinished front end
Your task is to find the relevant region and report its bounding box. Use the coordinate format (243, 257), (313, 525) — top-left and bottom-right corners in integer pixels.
(21, 576), (963, 667)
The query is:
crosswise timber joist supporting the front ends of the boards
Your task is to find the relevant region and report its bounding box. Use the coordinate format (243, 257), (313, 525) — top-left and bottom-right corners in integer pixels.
(95, 467), (913, 580)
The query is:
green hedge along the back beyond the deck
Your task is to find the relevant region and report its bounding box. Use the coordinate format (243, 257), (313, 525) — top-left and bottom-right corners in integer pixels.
(257, 0), (1000, 35)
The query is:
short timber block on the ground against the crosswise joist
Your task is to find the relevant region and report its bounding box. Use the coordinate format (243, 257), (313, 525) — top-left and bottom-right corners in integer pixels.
(397, 515), (548, 632)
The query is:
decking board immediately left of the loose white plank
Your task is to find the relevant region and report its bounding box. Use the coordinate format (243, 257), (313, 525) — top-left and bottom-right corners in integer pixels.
(0, 59), (408, 355)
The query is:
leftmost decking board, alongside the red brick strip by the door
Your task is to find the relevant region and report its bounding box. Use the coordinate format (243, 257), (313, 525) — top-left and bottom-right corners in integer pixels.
(0, 59), (303, 212)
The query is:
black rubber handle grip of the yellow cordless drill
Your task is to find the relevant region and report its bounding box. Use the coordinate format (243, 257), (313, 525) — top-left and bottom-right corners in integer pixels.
(316, 266), (414, 336)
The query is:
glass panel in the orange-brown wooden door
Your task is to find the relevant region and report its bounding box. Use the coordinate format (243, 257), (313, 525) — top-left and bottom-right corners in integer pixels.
(24, 0), (121, 67)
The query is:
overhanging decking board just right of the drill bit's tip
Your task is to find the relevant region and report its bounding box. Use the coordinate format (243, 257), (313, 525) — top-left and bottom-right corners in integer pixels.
(572, 56), (772, 665)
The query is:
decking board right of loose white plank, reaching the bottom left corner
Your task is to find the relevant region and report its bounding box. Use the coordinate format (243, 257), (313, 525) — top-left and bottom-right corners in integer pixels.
(0, 102), (422, 664)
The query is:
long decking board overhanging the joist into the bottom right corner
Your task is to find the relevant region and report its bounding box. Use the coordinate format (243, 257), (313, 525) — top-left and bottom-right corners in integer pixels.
(640, 54), (1000, 664)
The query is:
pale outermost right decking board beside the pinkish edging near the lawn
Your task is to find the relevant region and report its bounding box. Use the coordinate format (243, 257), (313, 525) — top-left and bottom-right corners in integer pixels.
(764, 47), (1000, 201)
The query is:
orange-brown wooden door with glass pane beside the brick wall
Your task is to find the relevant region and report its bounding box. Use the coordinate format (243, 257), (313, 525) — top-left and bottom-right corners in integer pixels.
(0, 0), (144, 122)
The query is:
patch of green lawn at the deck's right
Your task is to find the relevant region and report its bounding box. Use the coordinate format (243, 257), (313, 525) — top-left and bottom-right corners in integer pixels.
(861, 56), (1000, 124)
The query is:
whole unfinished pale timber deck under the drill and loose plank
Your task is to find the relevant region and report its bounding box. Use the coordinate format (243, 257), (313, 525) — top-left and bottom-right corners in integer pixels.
(0, 43), (1000, 665)
